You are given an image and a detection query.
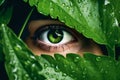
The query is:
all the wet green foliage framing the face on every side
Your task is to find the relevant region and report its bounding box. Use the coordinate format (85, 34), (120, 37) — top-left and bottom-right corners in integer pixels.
(0, 0), (120, 80)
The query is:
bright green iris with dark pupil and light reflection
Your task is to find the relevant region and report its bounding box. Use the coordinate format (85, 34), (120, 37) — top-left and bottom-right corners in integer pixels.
(47, 29), (63, 43)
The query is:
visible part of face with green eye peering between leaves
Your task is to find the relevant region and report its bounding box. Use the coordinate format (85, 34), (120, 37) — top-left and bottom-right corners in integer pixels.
(25, 20), (102, 56)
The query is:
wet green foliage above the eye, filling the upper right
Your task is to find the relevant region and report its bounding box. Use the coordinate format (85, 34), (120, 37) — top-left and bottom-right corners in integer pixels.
(24, 0), (120, 57)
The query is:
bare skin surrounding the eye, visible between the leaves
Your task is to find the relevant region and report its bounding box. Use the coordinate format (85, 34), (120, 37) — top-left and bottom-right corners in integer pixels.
(25, 20), (102, 56)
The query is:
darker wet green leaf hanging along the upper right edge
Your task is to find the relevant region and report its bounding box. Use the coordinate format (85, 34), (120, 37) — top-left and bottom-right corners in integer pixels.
(99, 0), (120, 57)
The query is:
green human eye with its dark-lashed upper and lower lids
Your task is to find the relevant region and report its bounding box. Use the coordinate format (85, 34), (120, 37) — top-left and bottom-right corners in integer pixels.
(33, 24), (77, 52)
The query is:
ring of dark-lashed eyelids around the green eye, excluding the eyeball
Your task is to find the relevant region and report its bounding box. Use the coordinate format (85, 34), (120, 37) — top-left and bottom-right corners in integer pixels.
(32, 24), (77, 52)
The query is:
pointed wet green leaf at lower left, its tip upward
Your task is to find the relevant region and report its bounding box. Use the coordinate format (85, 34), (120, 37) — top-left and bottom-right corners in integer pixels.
(0, 24), (44, 80)
